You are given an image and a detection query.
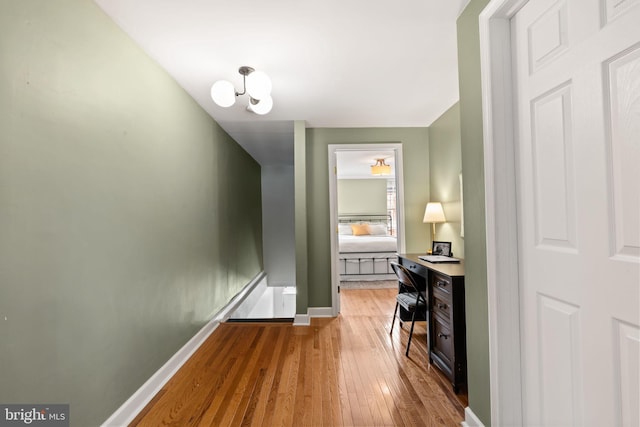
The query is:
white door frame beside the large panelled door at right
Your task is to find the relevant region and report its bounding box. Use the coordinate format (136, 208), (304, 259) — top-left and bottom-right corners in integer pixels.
(479, 0), (528, 425)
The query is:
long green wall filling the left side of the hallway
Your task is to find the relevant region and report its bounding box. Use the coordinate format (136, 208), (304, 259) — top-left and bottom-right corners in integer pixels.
(0, 0), (262, 426)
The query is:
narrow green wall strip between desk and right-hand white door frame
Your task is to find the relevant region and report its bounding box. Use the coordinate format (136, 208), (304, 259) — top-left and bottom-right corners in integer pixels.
(457, 0), (491, 426)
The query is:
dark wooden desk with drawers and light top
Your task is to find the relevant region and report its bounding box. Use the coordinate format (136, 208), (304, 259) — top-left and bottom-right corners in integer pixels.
(398, 254), (467, 393)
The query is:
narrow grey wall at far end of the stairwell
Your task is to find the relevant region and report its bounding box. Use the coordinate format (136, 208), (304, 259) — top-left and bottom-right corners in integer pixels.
(262, 166), (296, 286)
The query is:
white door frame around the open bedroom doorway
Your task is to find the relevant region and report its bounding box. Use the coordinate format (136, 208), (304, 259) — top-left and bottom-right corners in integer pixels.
(328, 143), (405, 316)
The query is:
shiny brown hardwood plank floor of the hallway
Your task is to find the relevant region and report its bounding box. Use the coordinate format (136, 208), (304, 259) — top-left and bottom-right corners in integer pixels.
(131, 289), (467, 427)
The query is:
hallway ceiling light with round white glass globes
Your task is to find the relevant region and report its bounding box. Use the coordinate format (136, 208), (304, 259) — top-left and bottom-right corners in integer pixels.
(211, 65), (273, 115)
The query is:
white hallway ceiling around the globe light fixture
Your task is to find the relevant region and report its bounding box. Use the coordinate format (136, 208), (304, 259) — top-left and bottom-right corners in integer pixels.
(95, 0), (468, 165)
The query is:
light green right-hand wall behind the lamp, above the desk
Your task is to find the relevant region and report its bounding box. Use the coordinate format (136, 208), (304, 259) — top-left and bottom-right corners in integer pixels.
(429, 102), (464, 258)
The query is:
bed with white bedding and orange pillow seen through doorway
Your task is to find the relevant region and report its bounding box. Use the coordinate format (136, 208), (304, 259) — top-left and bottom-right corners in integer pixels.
(338, 215), (398, 281)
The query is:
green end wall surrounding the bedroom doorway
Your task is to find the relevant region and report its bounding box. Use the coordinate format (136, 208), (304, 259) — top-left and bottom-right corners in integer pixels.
(304, 128), (430, 313)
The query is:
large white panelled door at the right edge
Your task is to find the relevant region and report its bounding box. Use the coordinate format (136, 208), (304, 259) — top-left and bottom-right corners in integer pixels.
(511, 0), (640, 426)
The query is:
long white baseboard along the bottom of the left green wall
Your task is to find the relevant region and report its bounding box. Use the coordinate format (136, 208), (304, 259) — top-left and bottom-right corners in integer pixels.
(101, 271), (266, 427)
